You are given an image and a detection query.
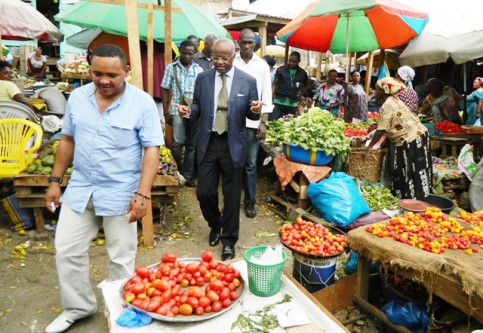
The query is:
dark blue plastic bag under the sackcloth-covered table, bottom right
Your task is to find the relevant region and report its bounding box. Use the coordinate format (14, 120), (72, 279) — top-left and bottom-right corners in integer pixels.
(381, 300), (429, 333)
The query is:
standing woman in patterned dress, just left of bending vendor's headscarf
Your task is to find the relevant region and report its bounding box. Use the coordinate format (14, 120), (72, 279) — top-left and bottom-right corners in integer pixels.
(344, 72), (367, 123)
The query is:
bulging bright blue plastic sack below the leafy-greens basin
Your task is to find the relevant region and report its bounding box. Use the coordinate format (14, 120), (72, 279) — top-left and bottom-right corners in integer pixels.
(307, 172), (371, 227)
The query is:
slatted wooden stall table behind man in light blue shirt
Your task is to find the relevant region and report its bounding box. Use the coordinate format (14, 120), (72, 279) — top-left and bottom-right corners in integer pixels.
(13, 173), (178, 244)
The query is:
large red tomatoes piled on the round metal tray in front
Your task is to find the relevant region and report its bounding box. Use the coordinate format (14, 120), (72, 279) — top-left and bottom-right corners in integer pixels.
(122, 251), (241, 317)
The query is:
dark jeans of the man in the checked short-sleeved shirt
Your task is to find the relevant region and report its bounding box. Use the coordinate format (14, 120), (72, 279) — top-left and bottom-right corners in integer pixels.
(171, 115), (199, 179)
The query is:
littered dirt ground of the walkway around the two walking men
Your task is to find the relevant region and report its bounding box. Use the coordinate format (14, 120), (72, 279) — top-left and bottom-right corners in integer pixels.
(0, 177), (291, 333)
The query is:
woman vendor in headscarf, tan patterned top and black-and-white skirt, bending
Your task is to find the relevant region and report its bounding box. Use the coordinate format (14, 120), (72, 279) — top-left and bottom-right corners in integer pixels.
(369, 77), (432, 199)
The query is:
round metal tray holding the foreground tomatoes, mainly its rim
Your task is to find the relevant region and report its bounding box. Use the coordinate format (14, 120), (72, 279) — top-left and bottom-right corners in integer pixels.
(119, 258), (247, 323)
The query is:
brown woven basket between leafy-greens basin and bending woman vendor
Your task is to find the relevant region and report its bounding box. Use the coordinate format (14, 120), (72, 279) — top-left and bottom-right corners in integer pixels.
(348, 148), (386, 183)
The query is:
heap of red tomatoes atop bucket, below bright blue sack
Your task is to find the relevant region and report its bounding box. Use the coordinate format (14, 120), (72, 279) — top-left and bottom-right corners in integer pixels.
(280, 217), (347, 257)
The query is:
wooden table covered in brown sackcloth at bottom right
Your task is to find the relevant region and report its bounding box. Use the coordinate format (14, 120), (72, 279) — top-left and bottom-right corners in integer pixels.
(347, 222), (483, 323)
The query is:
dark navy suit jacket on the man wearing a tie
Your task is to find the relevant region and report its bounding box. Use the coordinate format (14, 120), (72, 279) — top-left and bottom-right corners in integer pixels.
(190, 68), (260, 168)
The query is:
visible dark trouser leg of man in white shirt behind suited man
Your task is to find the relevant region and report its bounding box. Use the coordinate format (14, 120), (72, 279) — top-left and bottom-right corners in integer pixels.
(243, 128), (259, 204)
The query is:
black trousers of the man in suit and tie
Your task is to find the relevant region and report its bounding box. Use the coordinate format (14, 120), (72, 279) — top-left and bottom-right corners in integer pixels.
(196, 133), (243, 245)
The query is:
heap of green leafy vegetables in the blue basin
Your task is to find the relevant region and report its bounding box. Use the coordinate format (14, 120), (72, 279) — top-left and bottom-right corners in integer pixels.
(267, 108), (350, 156)
